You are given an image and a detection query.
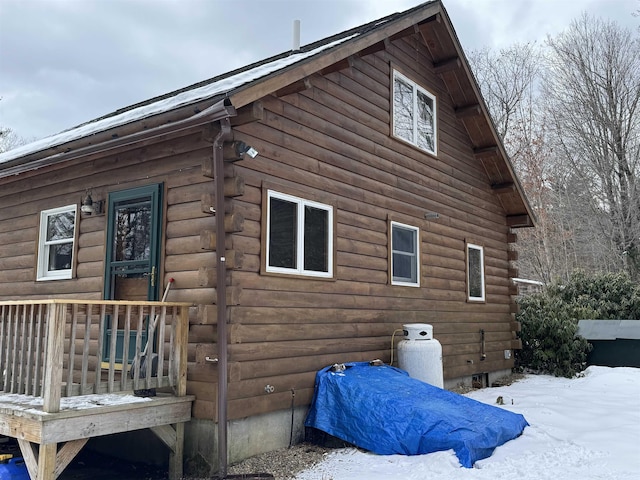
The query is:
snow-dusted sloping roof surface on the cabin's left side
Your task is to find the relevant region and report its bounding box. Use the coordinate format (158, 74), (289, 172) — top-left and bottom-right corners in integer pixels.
(0, 2), (434, 170)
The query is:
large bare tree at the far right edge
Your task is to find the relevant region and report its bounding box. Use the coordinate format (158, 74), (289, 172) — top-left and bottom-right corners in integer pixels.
(544, 14), (640, 279)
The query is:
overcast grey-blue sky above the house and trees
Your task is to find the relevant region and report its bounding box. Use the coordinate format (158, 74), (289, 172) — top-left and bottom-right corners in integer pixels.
(0, 0), (640, 140)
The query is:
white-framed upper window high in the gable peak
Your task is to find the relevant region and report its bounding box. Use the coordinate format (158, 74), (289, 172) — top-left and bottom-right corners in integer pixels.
(392, 70), (438, 155)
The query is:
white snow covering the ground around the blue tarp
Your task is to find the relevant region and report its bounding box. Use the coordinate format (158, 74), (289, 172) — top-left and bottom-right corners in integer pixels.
(295, 366), (640, 480)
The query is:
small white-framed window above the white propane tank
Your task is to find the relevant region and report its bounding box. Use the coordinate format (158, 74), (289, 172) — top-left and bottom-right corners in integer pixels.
(391, 222), (420, 287)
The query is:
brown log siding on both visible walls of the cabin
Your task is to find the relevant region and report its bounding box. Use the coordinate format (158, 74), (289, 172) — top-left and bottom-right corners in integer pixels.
(0, 36), (515, 419)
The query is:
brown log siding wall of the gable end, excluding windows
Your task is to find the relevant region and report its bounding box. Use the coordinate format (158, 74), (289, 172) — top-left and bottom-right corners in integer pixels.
(222, 37), (514, 417)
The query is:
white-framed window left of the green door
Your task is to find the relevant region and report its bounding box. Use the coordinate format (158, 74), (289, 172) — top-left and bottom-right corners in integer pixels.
(36, 205), (77, 280)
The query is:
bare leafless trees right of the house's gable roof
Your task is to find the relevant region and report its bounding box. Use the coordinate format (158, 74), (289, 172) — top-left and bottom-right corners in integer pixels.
(469, 16), (640, 281)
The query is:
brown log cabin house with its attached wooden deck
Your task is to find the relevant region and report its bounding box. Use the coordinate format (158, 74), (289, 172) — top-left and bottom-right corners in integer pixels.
(0, 1), (533, 480)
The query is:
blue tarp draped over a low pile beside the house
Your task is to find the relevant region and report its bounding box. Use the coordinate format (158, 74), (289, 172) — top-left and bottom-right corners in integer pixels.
(305, 362), (529, 468)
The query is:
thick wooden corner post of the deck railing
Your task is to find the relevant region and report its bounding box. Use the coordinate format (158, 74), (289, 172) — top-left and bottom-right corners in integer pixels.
(42, 302), (66, 413)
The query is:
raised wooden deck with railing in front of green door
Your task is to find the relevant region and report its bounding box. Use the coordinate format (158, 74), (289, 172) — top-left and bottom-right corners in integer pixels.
(0, 300), (194, 480)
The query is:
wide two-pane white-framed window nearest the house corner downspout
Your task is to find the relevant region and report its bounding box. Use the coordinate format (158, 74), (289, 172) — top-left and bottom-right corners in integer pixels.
(266, 190), (333, 278)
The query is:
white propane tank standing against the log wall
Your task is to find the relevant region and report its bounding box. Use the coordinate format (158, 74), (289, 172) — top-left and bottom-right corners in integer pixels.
(398, 323), (444, 388)
